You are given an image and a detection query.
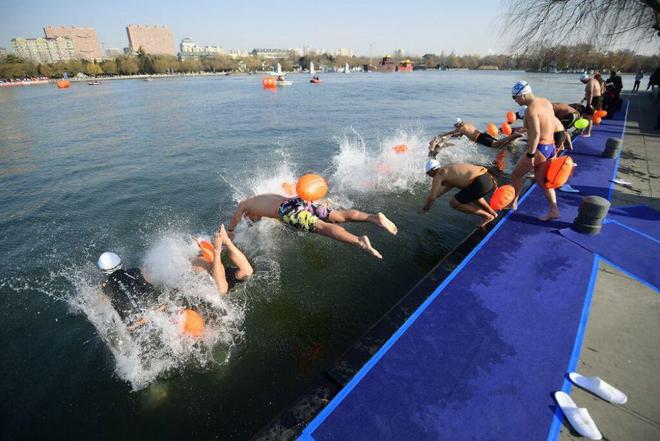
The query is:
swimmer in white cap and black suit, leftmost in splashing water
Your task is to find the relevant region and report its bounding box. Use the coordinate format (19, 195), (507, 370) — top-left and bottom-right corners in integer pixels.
(97, 252), (163, 331)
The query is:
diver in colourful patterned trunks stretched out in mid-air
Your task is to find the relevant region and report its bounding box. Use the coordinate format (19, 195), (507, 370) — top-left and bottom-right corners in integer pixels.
(227, 194), (397, 259)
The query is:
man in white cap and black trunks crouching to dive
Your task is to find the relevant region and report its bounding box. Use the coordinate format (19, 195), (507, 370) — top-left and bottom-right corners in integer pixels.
(419, 159), (497, 227)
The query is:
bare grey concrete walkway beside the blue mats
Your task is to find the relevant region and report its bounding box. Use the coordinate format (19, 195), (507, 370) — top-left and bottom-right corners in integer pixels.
(560, 93), (660, 441)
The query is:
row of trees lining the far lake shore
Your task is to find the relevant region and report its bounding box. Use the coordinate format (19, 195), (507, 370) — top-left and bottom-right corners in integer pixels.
(0, 44), (660, 78)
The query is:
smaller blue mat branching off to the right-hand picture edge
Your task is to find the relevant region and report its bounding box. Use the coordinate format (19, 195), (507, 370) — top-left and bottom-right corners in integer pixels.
(560, 221), (660, 290)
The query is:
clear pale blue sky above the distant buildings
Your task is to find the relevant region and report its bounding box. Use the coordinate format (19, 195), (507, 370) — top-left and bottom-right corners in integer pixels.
(0, 0), (658, 56)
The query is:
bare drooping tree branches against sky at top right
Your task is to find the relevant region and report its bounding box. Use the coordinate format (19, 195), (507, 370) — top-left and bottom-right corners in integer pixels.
(502, 0), (660, 51)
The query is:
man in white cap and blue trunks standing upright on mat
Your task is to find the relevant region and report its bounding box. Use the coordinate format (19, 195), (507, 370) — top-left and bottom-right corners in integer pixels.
(511, 80), (560, 221)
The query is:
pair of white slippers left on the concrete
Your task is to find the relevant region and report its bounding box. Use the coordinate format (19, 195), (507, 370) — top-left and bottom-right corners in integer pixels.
(555, 372), (628, 440)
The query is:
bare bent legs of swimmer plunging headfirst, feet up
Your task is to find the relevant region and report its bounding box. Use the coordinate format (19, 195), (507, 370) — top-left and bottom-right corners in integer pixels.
(192, 225), (254, 294)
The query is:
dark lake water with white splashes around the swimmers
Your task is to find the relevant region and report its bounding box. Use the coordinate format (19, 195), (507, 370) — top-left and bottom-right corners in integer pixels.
(0, 71), (628, 440)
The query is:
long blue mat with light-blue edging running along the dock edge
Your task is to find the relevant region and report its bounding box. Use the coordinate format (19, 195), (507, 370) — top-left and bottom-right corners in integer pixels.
(301, 104), (623, 441)
